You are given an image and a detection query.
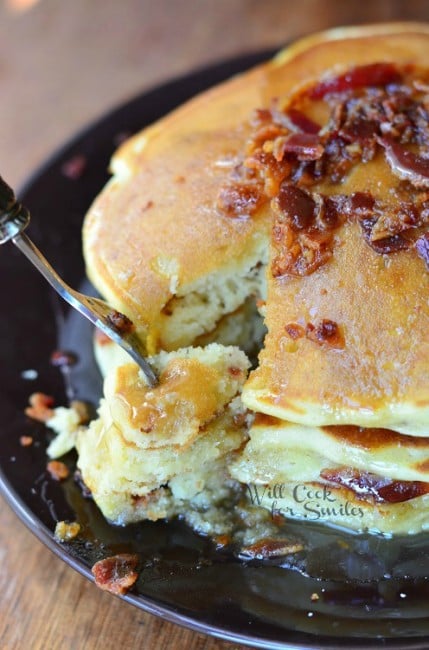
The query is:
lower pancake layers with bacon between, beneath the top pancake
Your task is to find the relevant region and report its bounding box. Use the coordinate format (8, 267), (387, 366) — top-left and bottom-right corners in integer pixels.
(229, 415), (429, 535)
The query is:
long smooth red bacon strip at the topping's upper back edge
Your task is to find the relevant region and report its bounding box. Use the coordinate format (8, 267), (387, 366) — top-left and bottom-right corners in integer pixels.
(308, 63), (402, 99)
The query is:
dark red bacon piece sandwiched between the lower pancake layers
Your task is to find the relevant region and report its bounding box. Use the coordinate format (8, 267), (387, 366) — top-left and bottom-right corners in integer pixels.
(320, 467), (429, 503)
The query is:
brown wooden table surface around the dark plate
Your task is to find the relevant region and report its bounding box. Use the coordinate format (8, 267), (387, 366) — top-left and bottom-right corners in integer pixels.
(0, 0), (429, 650)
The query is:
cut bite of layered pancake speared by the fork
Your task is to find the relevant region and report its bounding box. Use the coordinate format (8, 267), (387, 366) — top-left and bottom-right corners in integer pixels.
(76, 344), (249, 524)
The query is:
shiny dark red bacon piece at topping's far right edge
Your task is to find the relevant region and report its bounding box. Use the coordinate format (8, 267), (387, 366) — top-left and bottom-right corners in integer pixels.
(378, 135), (429, 187)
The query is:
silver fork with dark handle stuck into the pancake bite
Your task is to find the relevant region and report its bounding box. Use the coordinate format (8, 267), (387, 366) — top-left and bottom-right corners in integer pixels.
(0, 176), (158, 387)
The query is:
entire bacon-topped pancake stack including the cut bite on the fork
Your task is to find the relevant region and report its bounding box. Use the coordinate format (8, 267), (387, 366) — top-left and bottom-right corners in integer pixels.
(46, 23), (429, 540)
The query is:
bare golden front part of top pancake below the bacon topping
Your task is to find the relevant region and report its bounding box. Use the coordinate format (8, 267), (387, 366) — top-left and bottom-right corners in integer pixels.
(243, 214), (429, 436)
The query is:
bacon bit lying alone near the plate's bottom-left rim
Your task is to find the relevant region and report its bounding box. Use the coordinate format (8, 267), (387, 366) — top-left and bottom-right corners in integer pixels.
(91, 553), (138, 596)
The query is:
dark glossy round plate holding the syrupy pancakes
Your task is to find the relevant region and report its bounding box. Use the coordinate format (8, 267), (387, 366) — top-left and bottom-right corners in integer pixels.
(0, 52), (429, 650)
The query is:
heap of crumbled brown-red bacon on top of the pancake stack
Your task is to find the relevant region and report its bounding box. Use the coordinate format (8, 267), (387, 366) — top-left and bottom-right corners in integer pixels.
(218, 62), (429, 277)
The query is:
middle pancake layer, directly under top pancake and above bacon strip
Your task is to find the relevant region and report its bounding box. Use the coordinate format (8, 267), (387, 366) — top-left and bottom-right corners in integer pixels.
(232, 415), (429, 484)
